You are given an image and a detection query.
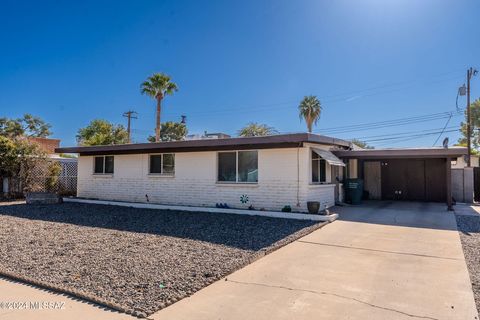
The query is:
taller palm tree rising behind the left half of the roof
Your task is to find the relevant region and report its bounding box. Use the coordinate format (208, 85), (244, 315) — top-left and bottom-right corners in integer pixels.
(141, 73), (178, 142)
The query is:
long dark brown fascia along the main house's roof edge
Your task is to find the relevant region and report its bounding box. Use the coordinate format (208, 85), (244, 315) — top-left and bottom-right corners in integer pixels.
(55, 133), (350, 156)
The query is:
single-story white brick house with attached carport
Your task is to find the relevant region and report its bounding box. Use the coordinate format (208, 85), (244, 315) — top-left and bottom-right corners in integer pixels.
(56, 133), (466, 212)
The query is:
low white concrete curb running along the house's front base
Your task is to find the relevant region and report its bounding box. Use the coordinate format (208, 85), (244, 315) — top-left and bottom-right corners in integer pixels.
(63, 198), (338, 222)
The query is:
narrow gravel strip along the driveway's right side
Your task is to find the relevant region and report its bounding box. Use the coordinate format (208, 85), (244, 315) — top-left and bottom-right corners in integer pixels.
(456, 215), (480, 310)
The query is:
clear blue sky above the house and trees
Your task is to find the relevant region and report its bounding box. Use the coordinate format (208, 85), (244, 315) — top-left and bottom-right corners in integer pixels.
(0, 0), (480, 147)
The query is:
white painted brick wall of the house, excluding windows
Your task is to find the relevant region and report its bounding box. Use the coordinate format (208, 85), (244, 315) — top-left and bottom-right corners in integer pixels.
(77, 147), (334, 212)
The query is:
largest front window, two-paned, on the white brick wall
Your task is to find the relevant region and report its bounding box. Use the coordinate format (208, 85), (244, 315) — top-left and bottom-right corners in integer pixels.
(217, 150), (258, 183)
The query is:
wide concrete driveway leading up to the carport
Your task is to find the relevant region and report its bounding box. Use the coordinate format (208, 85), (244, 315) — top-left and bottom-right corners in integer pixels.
(155, 202), (478, 320)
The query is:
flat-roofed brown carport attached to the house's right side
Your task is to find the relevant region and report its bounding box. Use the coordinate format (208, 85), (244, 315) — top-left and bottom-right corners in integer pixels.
(334, 147), (467, 210)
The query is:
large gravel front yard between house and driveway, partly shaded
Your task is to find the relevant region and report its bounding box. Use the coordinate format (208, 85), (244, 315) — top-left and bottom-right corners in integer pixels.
(0, 203), (322, 315)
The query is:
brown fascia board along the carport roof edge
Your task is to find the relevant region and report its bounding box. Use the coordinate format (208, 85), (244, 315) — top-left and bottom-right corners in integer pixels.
(332, 148), (467, 160)
